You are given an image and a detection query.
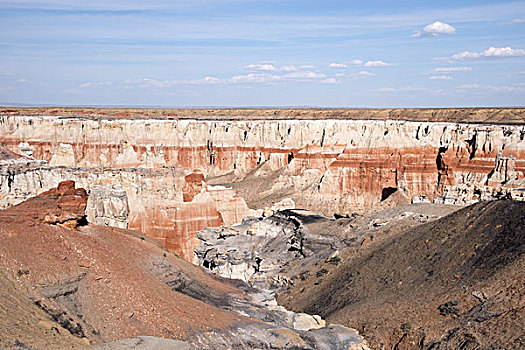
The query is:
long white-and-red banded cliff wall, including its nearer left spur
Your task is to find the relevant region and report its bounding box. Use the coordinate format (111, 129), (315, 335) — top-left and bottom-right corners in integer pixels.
(0, 115), (525, 259)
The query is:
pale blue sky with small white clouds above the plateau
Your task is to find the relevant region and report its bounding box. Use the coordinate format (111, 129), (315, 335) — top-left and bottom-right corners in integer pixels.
(0, 0), (525, 108)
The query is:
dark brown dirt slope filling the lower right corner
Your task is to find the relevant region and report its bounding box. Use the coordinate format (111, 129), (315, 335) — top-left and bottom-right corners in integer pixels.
(280, 200), (525, 349)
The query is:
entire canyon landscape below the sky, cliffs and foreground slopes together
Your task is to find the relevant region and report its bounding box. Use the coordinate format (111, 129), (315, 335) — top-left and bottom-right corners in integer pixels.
(0, 108), (525, 350)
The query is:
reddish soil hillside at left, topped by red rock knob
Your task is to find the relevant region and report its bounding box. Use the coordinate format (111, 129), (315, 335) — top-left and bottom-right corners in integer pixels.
(0, 183), (246, 347)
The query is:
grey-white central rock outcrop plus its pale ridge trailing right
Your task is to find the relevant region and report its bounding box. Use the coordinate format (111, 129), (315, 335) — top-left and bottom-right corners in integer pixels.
(193, 204), (457, 294)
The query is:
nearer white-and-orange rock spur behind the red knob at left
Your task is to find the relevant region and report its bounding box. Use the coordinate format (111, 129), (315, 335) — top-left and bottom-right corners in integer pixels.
(0, 158), (251, 260)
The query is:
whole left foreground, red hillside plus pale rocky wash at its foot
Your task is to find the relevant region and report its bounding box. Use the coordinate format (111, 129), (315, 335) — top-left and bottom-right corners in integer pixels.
(0, 185), (368, 350)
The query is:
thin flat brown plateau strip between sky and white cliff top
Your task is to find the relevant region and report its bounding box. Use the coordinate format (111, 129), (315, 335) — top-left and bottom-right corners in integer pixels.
(4, 107), (525, 125)
